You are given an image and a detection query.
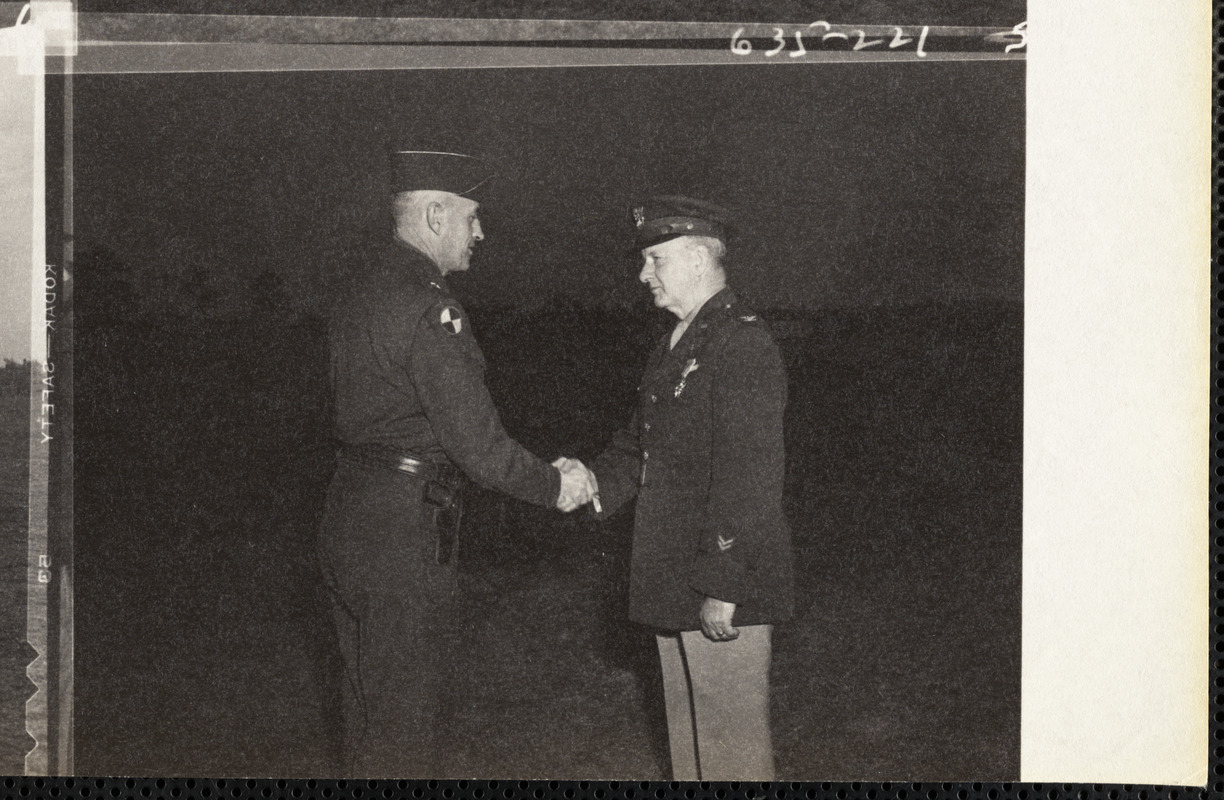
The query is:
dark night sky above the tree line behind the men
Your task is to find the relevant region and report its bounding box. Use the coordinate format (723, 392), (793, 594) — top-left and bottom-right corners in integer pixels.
(64, 62), (1024, 327)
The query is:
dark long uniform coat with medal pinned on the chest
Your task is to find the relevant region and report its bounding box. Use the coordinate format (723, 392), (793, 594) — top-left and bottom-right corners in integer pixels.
(592, 289), (794, 630)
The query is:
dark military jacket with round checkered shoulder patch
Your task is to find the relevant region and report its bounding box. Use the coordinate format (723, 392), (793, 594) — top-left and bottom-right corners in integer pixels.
(329, 240), (561, 506)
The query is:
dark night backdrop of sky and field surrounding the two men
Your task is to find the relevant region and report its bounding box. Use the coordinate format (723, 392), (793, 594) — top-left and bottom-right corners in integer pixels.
(2, 34), (1024, 779)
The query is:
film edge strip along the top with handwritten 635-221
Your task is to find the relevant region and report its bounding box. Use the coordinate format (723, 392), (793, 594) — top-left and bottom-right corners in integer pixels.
(49, 11), (1028, 73)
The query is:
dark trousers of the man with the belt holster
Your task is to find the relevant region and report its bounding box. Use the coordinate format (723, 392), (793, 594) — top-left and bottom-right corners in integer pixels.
(319, 462), (455, 778)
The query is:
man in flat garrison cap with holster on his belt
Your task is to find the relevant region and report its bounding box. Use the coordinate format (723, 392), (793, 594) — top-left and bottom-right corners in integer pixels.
(319, 150), (594, 778)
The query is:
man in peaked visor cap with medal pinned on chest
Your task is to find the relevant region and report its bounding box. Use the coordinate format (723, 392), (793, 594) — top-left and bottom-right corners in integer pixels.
(592, 197), (793, 780)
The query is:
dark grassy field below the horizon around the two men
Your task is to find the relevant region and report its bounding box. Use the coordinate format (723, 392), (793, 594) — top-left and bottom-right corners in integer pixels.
(9, 297), (1022, 780)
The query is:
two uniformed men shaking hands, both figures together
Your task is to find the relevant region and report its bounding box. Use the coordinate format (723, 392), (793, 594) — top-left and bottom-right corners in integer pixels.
(319, 150), (793, 780)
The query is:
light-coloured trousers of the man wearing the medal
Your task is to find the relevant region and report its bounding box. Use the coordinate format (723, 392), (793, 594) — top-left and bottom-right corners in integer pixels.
(656, 625), (774, 780)
